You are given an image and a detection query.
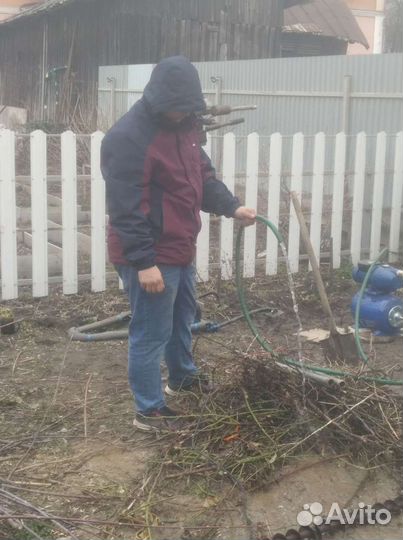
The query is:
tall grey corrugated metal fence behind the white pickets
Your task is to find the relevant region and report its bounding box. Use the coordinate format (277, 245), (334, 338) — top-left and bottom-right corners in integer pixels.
(99, 54), (403, 205)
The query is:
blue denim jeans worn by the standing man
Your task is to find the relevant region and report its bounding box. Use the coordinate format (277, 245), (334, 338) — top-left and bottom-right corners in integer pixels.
(116, 264), (197, 413)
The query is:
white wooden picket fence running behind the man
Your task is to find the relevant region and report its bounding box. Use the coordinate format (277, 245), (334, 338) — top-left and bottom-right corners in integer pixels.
(0, 130), (403, 300)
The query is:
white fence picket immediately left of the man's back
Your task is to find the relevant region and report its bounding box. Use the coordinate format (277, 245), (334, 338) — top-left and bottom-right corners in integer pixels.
(91, 131), (106, 292)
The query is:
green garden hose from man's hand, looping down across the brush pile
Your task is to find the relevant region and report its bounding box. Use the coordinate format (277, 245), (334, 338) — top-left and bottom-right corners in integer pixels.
(235, 216), (403, 386)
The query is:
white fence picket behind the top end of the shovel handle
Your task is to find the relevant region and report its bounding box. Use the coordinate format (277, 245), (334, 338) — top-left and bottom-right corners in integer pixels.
(288, 133), (304, 272)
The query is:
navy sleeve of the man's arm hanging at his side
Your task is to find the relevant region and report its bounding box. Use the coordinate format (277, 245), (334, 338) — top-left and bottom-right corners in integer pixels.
(101, 131), (155, 270)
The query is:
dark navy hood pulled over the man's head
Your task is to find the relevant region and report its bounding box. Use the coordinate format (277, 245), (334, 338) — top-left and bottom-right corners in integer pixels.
(144, 56), (206, 114)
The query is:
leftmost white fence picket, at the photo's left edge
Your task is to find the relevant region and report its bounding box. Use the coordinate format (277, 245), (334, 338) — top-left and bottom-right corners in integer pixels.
(0, 129), (18, 300)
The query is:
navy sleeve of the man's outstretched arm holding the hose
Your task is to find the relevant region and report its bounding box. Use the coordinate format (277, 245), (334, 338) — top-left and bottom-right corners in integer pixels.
(201, 149), (241, 217)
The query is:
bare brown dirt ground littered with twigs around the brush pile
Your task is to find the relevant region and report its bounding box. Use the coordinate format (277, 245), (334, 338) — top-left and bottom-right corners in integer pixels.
(0, 270), (403, 540)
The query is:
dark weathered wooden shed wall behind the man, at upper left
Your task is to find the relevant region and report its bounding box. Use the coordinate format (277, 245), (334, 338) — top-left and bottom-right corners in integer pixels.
(0, 0), (298, 129)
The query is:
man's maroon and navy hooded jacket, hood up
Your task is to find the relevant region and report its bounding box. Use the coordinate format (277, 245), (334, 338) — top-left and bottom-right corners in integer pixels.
(101, 56), (240, 270)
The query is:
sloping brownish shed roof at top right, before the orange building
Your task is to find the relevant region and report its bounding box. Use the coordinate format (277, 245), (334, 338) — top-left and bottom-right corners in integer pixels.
(283, 0), (369, 49)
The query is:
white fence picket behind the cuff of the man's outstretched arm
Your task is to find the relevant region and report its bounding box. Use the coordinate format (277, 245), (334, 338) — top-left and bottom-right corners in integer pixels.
(220, 133), (235, 279)
